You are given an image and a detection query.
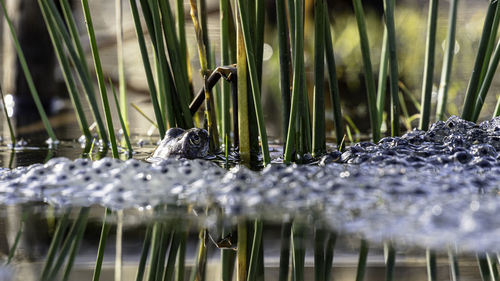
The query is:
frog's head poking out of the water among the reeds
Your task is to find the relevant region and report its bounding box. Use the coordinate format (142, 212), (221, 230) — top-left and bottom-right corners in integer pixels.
(150, 128), (209, 161)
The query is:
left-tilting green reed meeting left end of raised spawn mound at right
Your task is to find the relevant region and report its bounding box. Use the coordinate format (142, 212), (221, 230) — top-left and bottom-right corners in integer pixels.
(352, 0), (380, 142)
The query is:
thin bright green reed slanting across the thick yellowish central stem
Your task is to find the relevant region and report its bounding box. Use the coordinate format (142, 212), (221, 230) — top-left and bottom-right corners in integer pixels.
(238, 0), (271, 166)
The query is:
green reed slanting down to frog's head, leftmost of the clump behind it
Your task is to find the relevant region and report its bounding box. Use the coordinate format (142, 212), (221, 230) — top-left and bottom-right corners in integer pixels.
(130, 0), (166, 138)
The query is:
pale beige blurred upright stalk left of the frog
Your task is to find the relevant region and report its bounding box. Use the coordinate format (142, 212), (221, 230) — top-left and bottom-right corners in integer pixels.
(115, 0), (128, 128)
